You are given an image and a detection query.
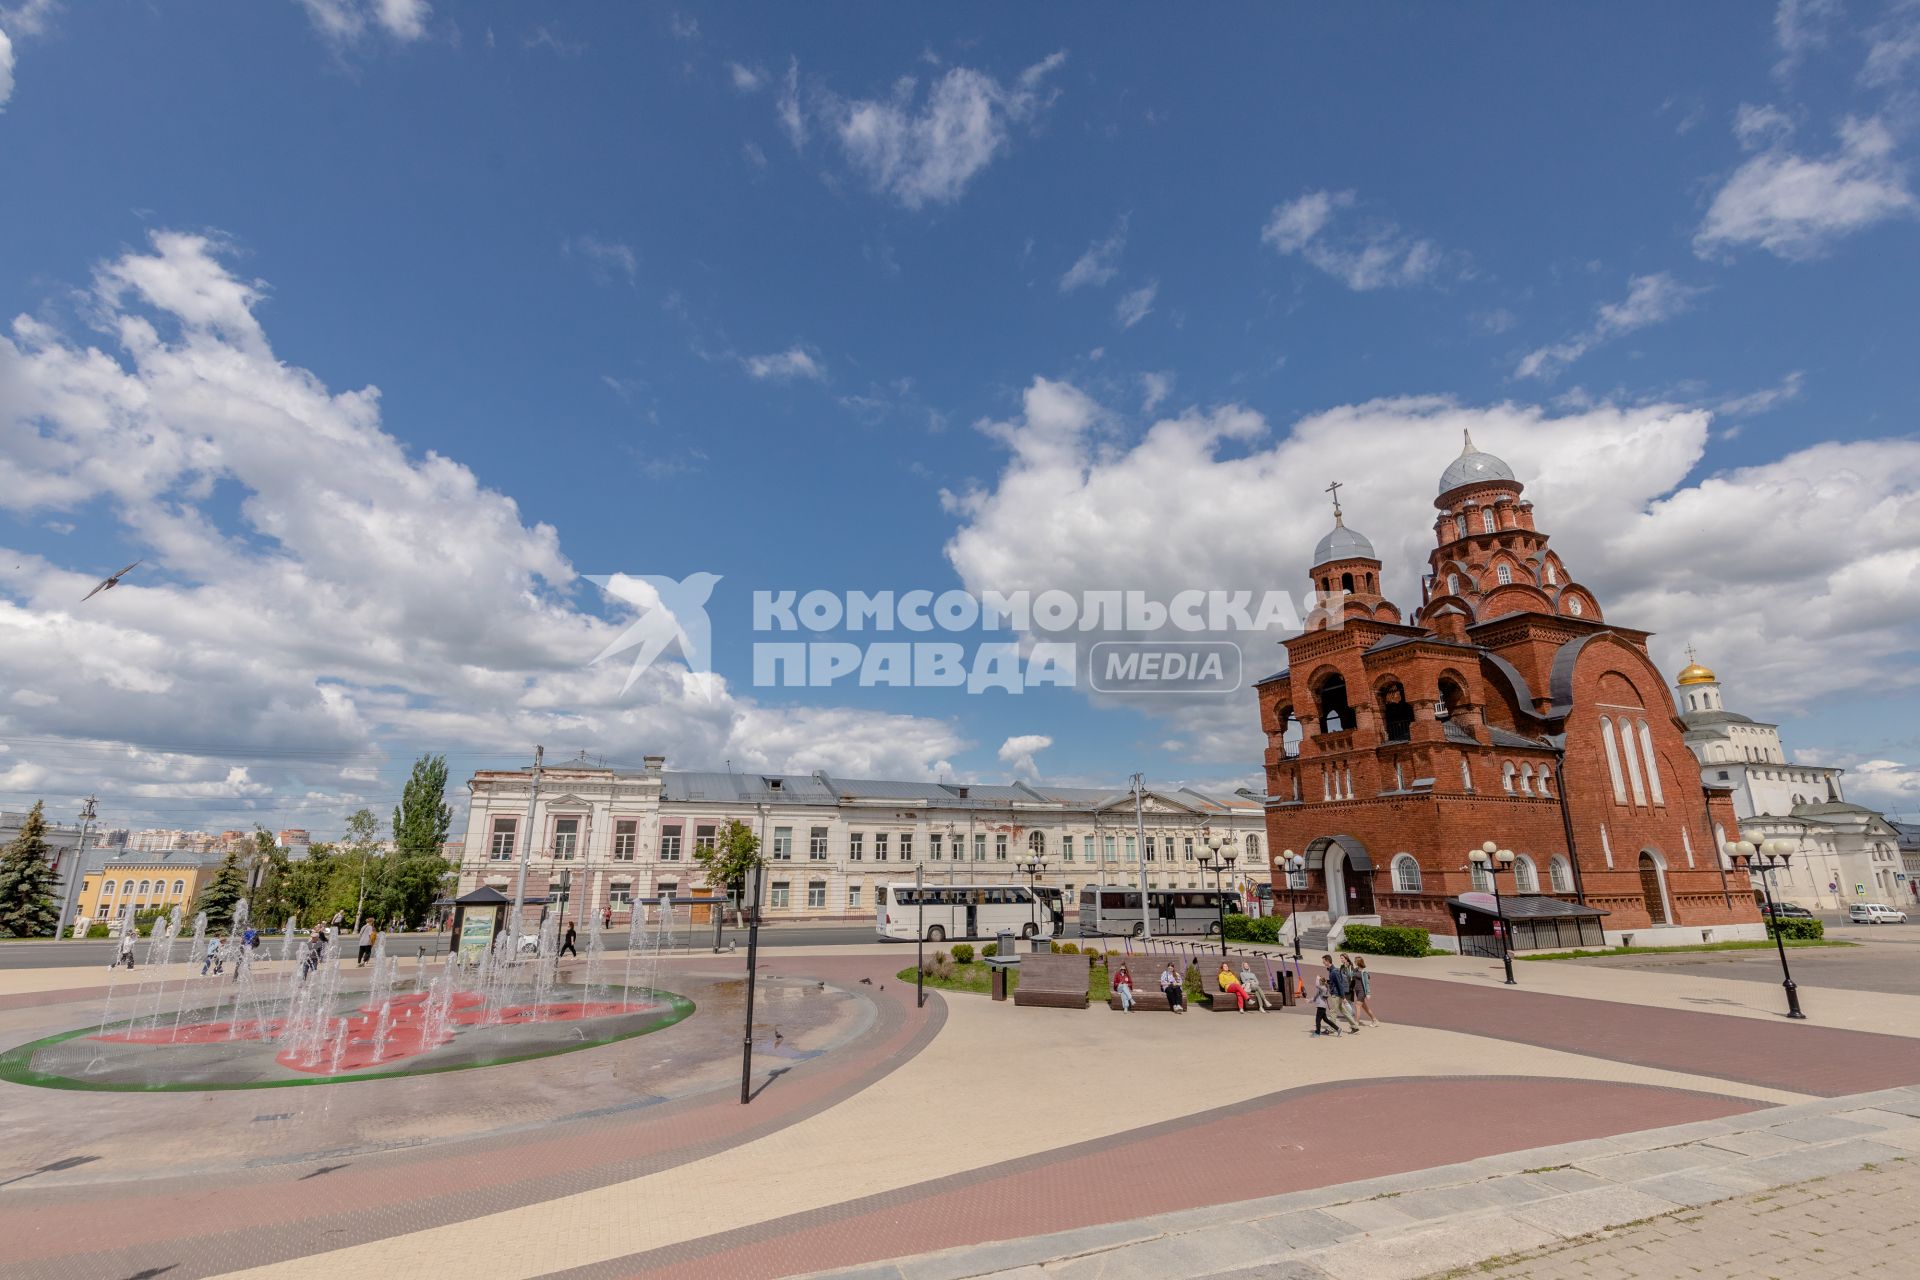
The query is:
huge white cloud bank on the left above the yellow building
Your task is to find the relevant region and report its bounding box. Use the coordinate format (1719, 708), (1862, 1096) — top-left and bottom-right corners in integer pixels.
(0, 232), (964, 825)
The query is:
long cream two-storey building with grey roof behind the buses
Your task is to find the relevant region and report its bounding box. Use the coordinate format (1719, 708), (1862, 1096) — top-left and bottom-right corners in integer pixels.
(459, 756), (1271, 921)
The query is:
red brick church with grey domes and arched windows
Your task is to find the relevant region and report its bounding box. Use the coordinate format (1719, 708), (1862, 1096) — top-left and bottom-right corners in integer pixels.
(1258, 436), (1763, 950)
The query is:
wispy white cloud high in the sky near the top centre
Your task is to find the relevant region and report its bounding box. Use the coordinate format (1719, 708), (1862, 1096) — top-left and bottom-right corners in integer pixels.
(828, 52), (1066, 209)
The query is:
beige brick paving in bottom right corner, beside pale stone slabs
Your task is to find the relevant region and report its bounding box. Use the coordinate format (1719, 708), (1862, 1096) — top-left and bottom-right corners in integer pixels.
(1450, 1159), (1920, 1280)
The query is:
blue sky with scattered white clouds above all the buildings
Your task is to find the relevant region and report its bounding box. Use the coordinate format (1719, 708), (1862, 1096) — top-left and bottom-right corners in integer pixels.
(0, 0), (1920, 829)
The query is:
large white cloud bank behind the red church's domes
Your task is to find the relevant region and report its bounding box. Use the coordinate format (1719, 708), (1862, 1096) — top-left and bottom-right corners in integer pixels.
(947, 378), (1920, 762)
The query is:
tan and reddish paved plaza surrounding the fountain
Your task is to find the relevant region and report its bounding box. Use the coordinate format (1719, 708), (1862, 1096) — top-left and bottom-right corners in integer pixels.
(0, 932), (1920, 1280)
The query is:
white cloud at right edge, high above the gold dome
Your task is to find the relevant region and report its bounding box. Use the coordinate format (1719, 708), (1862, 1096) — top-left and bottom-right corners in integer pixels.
(1693, 117), (1916, 259)
